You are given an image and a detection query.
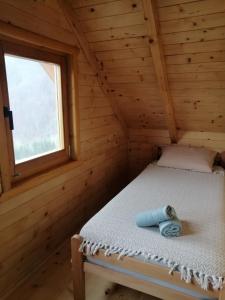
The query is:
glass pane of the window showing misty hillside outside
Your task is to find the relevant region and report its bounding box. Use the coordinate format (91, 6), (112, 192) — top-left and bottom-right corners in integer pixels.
(5, 54), (64, 164)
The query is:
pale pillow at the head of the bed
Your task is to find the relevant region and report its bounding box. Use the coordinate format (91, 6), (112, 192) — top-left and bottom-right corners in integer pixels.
(157, 145), (216, 173)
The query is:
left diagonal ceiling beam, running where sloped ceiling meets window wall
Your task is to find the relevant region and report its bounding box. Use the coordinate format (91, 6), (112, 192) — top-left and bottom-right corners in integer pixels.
(58, 0), (127, 134)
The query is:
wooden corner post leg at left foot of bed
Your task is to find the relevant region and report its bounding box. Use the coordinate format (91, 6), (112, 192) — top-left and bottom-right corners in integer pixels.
(71, 235), (85, 300)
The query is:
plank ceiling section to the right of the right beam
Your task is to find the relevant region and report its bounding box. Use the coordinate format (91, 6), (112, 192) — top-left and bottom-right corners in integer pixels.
(158, 0), (225, 132)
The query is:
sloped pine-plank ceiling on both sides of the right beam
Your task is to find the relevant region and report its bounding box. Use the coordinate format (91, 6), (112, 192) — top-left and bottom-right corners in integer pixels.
(69, 0), (225, 132)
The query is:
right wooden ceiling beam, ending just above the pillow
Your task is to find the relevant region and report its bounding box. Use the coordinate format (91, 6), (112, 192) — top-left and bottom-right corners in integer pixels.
(142, 0), (177, 143)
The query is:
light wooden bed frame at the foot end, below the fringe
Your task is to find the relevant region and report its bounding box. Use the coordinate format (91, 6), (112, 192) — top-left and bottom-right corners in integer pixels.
(71, 235), (225, 300)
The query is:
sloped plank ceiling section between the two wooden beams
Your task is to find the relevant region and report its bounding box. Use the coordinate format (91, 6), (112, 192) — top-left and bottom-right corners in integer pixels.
(70, 0), (166, 129)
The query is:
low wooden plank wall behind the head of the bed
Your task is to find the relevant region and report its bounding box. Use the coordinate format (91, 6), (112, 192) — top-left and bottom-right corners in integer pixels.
(128, 126), (225, 179)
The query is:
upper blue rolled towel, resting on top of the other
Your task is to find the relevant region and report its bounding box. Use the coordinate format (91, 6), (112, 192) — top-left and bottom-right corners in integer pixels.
(136, 205), (176, 227)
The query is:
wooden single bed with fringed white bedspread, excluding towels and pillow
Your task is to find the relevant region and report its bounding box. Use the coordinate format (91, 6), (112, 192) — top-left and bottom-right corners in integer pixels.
(72, 164), (225, 300)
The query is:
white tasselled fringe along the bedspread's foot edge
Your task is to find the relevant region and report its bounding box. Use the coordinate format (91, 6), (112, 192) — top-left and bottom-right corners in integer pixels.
(79, 239), (225, 290)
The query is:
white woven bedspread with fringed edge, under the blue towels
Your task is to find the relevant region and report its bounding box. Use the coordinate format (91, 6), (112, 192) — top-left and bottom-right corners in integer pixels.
(80, 165), (225, 289)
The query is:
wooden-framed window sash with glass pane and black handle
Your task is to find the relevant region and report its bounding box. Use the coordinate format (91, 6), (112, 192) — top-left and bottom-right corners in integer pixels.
(0, 41), (70, 182)
